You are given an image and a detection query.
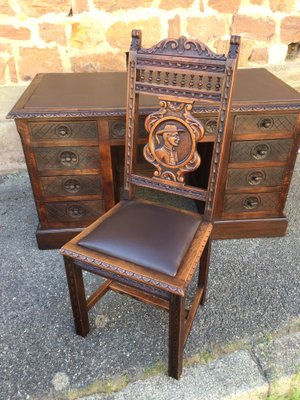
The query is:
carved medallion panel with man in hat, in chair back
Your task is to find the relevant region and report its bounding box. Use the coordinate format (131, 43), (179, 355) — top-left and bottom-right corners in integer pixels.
(144, 99), (204, 183)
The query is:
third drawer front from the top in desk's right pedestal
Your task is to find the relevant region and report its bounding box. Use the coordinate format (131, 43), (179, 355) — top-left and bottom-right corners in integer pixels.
(226, 167), (284, 189)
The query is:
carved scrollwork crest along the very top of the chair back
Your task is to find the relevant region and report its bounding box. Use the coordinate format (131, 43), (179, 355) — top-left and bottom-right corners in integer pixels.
(139, 36), (226, 60)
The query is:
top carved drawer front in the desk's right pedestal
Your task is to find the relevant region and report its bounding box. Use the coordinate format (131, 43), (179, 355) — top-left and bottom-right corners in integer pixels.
(233, 114), (297, 134)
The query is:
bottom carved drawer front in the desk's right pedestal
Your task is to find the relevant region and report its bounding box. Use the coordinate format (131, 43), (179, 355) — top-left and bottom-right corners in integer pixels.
(223, 192), (280, 214)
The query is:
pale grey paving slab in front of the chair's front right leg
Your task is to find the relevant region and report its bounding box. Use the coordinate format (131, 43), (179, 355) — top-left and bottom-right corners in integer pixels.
(81, 350), (269, 400)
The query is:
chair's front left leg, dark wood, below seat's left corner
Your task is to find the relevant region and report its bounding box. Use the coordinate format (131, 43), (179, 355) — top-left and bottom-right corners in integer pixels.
(64, 257), (90, 336)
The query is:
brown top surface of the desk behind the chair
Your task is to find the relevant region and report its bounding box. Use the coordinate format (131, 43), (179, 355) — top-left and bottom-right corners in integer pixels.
(7, 68), (300, 118)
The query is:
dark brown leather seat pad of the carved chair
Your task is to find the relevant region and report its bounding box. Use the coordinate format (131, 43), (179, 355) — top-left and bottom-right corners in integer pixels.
(78, 200), (201, 276)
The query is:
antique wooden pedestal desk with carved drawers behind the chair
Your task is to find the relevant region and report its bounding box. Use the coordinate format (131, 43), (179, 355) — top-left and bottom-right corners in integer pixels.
(7, 69), (300, 249)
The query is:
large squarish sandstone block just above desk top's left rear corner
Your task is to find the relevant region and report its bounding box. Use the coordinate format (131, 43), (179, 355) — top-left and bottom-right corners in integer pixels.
(19, 47), (63, 81)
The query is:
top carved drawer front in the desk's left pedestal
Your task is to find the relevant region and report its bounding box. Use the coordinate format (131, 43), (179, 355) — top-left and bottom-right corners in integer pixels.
(29, 121), (98, 142)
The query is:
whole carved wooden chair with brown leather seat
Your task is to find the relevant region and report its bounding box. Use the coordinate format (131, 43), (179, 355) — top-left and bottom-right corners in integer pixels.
(61, 30), (239, 379)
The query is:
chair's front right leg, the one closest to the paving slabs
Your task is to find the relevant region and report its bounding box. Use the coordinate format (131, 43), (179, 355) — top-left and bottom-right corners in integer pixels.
(168, 294), (185, 379)
